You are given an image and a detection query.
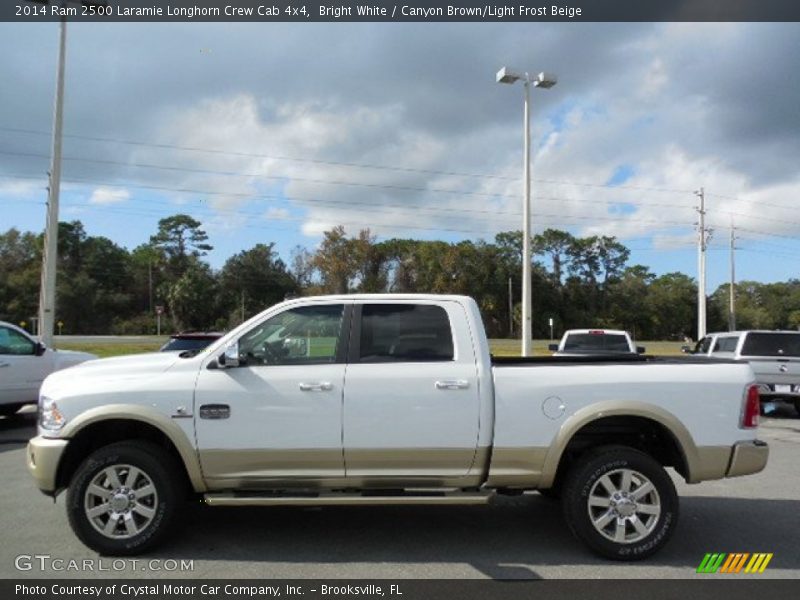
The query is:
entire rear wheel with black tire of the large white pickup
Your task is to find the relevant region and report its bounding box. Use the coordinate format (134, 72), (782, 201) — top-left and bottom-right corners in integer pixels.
(562, 446), (678, 561)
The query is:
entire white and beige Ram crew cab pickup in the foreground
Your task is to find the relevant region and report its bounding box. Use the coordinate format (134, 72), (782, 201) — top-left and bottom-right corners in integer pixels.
(27, 295), (768, 560)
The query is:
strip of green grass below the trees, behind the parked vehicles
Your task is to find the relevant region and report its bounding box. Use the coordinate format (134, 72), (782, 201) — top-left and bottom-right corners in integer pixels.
(58, 336), (683, 358)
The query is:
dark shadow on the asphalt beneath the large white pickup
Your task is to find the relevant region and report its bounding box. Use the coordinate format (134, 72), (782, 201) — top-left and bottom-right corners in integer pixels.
(147, 495), (800, 579)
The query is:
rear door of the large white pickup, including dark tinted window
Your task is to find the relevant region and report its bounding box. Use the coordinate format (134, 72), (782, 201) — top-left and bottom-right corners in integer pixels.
(343, 300), (479, 483)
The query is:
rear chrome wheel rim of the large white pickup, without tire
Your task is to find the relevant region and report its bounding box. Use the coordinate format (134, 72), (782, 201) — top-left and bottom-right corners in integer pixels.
(587, 469), (661, 544)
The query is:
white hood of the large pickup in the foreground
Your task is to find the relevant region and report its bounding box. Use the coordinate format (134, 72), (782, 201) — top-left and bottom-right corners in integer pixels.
(42, 350), (183, 394)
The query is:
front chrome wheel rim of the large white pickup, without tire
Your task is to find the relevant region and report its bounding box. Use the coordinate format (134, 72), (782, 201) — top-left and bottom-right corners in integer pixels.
(83, 465), (158, 540)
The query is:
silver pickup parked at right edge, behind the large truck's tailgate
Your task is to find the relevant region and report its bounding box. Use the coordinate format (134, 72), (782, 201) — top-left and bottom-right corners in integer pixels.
(687, 330), (800, 413)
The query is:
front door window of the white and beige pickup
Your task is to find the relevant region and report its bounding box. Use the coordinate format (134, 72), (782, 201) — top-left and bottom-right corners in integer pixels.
(234, 304), (344, 367)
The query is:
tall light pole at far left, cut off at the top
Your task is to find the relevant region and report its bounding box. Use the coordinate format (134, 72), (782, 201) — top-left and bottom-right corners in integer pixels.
(29, 0), (107, 347)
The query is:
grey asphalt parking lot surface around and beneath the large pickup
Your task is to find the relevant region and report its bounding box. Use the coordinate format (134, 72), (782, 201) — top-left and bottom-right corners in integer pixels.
(0, 408), (800, 579)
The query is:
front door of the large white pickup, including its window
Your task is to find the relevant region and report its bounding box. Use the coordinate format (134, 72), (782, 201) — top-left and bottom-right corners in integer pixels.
(194, 302), (350, 489)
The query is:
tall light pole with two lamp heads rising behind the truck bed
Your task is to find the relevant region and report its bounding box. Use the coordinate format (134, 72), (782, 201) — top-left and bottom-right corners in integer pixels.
(497, 67), (558, 356)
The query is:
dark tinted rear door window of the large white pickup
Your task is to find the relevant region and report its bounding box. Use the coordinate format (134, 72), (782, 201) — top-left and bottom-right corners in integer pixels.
(359, 304), (453, 362)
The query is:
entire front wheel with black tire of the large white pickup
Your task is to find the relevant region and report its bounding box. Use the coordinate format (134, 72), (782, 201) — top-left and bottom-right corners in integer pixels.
(67, 441), (184, 556)
